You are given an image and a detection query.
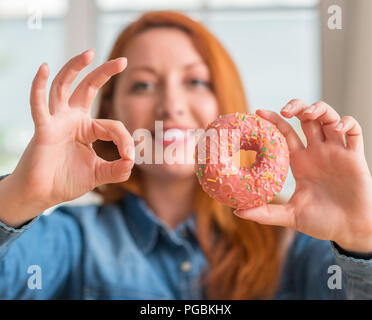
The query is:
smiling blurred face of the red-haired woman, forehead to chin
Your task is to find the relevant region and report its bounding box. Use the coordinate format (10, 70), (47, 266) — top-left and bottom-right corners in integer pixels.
(112, 27), (218, 179)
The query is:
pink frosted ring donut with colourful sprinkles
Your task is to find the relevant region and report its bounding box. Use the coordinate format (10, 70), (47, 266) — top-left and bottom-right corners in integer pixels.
(195, 113), (289, 209)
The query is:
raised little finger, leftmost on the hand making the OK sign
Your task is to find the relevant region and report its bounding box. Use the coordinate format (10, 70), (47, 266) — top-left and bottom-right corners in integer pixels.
(30, 63), (50, 126)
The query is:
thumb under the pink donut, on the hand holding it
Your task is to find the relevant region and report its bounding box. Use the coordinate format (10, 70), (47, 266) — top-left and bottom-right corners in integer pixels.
(234, 204), (295, 228)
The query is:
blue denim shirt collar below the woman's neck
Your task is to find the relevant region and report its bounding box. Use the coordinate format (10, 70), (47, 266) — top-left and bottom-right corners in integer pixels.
(120, 192), (196, 254)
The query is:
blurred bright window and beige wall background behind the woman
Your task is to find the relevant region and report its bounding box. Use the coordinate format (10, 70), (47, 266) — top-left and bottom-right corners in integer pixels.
(0, 0), (372, 203)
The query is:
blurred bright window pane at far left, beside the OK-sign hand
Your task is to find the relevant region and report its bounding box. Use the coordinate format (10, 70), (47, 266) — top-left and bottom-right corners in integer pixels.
(0, 0), (68, 174)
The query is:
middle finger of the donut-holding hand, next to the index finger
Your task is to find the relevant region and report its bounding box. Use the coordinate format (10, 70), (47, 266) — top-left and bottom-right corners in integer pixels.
(281, 99), (325, 145)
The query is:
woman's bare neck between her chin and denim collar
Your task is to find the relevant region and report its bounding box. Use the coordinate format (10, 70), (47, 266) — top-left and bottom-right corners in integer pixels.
(144, 175), (197, 229)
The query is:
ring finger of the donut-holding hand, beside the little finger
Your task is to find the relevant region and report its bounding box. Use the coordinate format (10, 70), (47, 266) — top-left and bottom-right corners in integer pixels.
(303, 101), (344, 145)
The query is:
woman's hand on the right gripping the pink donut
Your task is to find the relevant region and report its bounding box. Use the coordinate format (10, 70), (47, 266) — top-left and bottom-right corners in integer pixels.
(235, 100), (372, 252)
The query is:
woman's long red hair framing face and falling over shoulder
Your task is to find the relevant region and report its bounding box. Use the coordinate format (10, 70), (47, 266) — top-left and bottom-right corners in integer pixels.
(93, 11), (282, 299)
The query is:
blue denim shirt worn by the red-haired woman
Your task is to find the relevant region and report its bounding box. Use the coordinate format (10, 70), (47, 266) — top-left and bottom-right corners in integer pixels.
(0, 175), (372, 299)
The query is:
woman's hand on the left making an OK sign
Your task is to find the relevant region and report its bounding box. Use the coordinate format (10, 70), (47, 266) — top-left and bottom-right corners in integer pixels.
(0, 50), (134, 225)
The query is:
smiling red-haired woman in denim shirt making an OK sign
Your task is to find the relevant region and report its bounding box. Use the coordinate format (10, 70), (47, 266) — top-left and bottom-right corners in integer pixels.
(0, 12), (372, 299)
